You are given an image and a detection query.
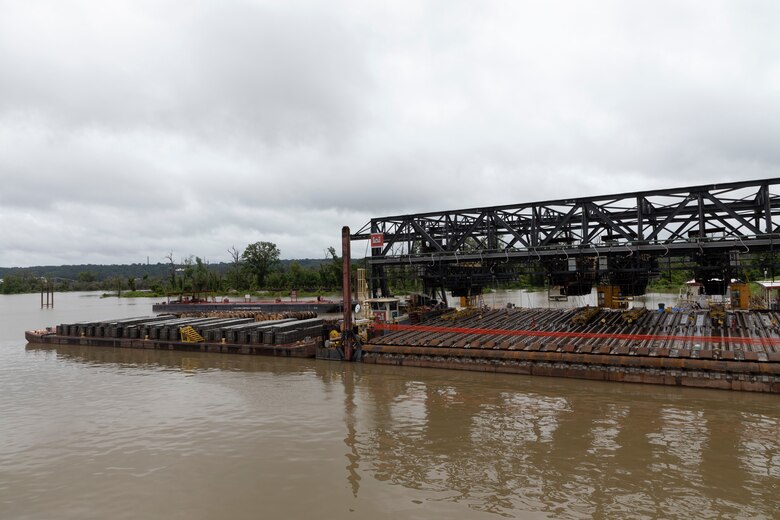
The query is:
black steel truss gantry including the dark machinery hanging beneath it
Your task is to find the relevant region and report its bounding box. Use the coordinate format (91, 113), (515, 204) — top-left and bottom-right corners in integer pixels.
(350, 178), (780, 300)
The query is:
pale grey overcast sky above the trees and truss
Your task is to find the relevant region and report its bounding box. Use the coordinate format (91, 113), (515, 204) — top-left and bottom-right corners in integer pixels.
(0, 0), (780, 267)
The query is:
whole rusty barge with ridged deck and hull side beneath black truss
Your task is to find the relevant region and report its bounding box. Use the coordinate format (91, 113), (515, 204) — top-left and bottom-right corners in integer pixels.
(362, 308), (780, 393)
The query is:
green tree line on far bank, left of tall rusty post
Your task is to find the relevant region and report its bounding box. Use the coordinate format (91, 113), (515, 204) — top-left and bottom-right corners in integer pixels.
(0, 242), (350, 295)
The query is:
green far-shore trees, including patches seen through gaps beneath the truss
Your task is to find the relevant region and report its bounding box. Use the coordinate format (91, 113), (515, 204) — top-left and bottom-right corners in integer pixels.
(0, 242), (771, 300)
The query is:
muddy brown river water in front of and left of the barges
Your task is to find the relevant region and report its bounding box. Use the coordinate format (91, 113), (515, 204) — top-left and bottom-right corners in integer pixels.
(0, 293), (780, 520)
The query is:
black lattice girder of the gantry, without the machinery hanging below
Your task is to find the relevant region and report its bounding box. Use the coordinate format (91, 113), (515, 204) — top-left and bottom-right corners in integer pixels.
(351, 178), (780, 263)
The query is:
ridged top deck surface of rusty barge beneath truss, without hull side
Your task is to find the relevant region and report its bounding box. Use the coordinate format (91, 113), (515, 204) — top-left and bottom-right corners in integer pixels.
(374, 308), (780, 352)
